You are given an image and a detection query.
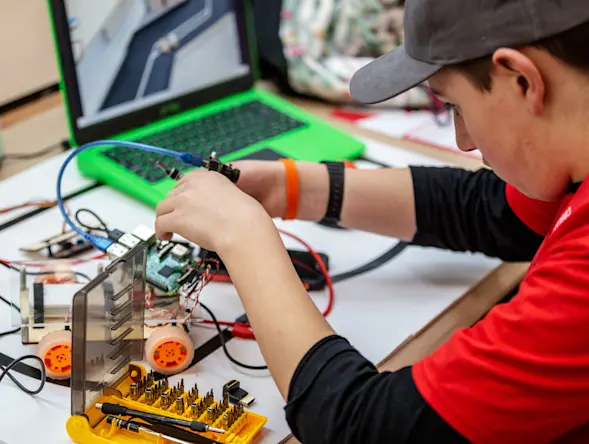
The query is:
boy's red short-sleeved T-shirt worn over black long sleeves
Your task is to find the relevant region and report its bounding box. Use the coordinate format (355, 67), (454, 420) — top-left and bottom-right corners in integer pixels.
(413, 180), (589, 444)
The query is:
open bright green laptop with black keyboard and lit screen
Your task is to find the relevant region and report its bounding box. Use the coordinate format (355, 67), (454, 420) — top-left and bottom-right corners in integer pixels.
(48, 0), (364, 207)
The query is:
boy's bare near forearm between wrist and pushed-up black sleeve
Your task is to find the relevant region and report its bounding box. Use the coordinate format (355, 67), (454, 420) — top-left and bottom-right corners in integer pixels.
(220, 219), (334, 399)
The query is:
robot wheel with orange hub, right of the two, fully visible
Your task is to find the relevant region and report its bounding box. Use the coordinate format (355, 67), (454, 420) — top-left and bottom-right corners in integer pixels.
(145, 325), (194, 375)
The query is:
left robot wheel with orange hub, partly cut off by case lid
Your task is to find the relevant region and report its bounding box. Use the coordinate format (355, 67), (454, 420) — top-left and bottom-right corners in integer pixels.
(37, 330), (72, 379)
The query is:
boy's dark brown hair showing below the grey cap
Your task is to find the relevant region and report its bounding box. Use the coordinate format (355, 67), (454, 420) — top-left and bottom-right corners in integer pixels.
(452, 22), (589, 92)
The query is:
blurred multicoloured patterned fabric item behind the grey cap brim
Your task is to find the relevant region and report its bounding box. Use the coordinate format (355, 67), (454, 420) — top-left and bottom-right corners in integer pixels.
(280, 0), (431, 108)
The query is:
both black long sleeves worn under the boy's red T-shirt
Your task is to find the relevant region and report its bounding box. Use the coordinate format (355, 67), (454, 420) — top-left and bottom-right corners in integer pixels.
(285, 167), (568, 444)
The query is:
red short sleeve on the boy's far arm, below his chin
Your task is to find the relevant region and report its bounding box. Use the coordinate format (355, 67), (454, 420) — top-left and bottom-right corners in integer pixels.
(505, 184), (561, 236)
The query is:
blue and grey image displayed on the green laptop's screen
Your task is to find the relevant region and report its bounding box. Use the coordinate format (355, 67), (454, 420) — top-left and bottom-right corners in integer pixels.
(66, 0), (250, 128)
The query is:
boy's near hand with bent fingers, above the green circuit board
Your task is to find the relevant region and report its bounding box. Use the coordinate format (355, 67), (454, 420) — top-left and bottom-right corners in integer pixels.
(155, 169), (272, 254)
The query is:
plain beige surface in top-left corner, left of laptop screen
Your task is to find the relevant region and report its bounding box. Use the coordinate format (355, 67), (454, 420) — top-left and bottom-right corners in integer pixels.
(0, 0), (58, 105)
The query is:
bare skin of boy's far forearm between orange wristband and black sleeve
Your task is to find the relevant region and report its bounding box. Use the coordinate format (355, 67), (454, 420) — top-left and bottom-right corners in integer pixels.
(297, 162), (416, 240)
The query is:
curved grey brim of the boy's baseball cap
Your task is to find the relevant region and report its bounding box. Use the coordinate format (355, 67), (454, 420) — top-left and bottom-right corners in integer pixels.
(350, 45), (443, 105)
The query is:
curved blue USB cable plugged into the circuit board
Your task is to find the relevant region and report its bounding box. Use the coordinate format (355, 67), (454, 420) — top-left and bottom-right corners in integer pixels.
(56, 140), (203, 251)
